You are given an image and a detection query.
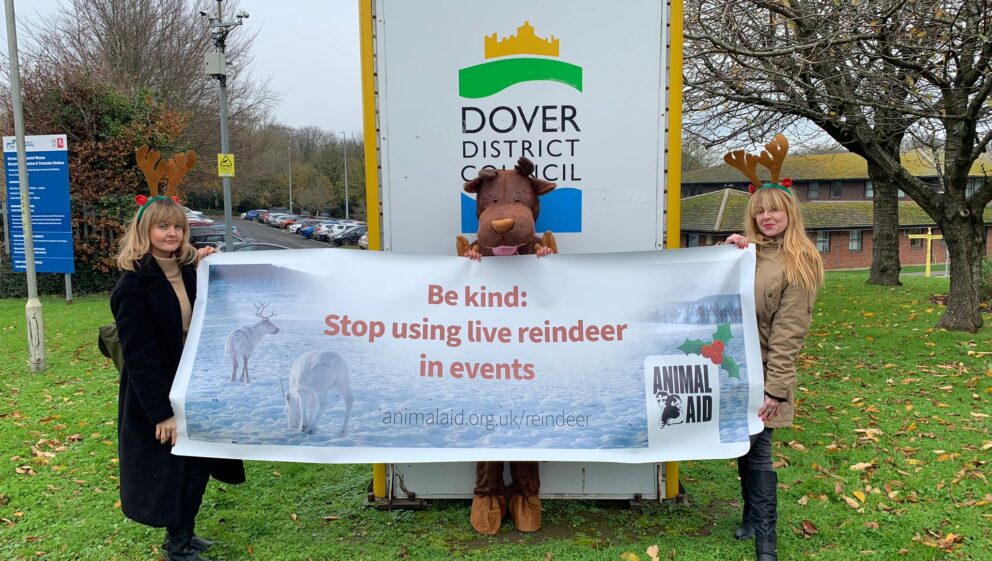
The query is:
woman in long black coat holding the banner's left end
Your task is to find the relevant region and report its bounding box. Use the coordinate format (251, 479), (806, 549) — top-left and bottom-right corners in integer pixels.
(110, 197), (245, 561)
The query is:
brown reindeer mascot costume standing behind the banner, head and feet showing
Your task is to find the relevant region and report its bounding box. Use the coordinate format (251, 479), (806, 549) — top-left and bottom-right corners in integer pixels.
(457, 158), (558, 534)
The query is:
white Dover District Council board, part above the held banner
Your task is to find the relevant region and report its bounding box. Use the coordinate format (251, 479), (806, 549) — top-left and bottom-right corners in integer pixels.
(376, 0), (668, 254)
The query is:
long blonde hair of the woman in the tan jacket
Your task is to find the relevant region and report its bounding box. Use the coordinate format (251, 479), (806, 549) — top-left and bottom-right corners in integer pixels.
(744, 187), (823, 294)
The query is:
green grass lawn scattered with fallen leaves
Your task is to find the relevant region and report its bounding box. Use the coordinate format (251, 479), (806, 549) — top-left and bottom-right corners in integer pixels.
(0, 271), (992, 561)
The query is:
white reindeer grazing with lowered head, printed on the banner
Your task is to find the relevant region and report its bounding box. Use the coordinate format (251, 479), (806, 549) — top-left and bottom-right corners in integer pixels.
(286, 351), (354, 436)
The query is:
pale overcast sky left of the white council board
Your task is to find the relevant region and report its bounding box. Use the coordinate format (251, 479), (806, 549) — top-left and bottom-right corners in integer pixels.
(0, 0), (362, 134)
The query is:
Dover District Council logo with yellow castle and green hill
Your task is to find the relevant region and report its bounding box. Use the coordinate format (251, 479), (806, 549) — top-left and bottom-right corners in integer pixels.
(458, 21), (583, 233)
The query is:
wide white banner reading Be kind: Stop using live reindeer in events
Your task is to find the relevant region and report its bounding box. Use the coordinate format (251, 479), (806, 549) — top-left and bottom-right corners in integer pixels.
(171, 246), (762, 463)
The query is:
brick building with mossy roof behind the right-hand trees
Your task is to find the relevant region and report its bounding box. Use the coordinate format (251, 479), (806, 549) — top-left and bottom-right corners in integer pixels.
(681, 152), (992, 269)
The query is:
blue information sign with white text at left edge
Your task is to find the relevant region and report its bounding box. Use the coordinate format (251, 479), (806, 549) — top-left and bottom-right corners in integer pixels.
(3, 134), (76, 273)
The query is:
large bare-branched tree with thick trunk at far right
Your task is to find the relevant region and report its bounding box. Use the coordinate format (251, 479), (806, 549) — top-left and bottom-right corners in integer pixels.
(686, 0), (992, 331)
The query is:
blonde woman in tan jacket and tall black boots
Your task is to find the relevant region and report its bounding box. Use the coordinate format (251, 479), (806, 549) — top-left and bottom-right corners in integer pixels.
(727, 185), (823, 561)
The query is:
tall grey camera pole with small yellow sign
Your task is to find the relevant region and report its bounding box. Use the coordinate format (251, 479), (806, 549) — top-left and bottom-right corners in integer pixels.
(200, 0), (248, 251)
